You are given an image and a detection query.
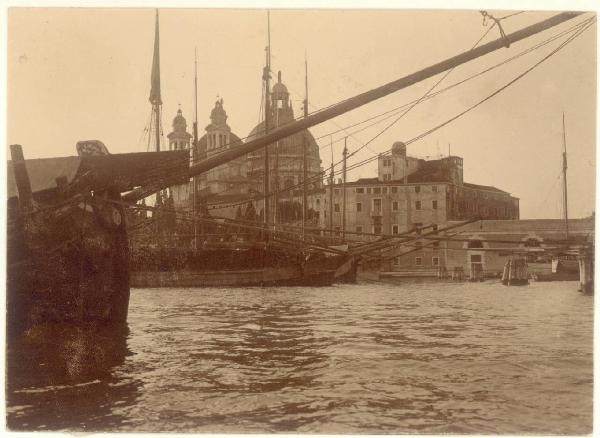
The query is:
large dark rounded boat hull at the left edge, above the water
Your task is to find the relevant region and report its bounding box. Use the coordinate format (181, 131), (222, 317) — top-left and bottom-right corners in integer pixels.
(7, 195), (129, 336)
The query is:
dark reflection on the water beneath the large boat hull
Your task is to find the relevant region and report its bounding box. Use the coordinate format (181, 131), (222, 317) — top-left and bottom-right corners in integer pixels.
(6, 324), (139, 430)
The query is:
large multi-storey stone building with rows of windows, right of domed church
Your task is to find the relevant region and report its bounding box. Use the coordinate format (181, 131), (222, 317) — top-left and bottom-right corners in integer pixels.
(313, 142), (519, 240)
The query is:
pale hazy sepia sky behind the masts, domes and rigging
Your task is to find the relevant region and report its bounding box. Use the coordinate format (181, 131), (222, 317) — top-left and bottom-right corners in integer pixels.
(7, 8), (596, 218)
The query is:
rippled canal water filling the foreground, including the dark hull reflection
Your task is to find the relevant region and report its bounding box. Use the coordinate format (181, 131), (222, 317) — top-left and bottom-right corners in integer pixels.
(7, 282), (593, 434)
